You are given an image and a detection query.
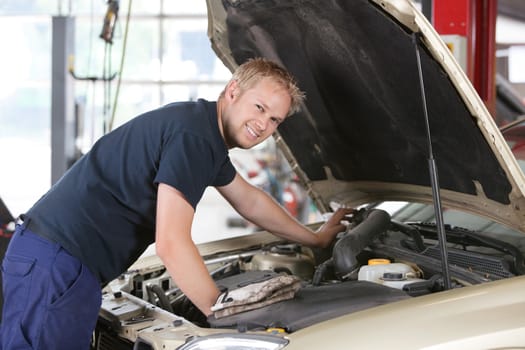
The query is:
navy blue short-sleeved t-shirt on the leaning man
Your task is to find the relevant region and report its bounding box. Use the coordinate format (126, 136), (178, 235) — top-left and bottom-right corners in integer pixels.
(27, 100), (235, 282)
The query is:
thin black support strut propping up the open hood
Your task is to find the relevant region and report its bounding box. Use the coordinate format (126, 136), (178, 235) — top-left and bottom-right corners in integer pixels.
(412, 33), (452, 290)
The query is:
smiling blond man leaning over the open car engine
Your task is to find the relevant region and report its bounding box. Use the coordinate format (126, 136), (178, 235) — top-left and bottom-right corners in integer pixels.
(0, 59), (350, 350)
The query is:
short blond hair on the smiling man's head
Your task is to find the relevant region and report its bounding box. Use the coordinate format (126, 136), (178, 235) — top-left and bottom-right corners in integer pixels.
(220, 57), (305, 116)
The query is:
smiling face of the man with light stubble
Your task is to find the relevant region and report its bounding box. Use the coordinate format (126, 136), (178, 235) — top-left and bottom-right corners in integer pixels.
(219, 78), (291, 149)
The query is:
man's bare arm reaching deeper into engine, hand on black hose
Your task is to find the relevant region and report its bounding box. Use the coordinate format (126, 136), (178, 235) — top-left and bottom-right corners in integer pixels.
(217, 174), (353, 247)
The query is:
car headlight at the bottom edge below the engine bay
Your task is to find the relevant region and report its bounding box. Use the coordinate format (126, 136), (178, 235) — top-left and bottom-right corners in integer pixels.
(177, 333), (288, 350)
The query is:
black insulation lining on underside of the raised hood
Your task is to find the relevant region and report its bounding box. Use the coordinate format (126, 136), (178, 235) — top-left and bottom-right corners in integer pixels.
(223, 0), (511, 204)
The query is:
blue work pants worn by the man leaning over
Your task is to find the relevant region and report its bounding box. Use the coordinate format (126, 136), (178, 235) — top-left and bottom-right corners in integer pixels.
(0, 226), (102, 350)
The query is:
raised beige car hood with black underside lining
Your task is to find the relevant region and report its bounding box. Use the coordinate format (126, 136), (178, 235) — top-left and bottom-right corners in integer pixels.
(207, 0), (525, 230)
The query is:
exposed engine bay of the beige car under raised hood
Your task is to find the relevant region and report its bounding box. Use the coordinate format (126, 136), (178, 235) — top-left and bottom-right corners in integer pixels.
(98, 209), (524, 348)
